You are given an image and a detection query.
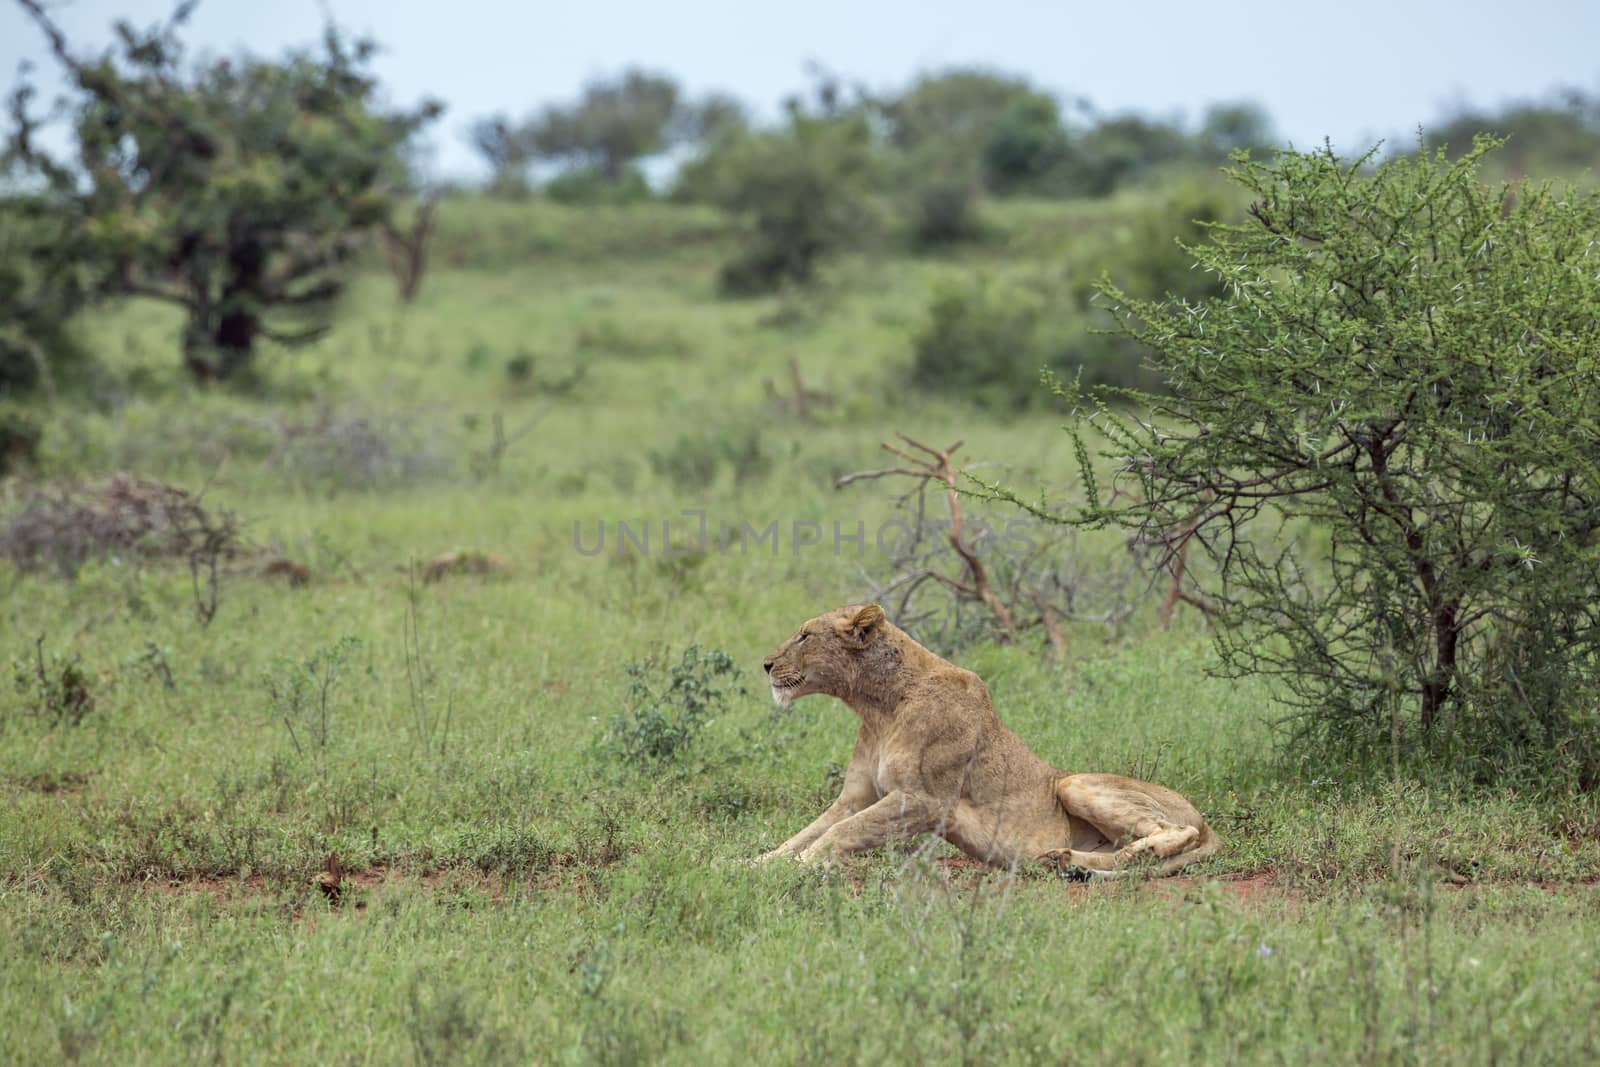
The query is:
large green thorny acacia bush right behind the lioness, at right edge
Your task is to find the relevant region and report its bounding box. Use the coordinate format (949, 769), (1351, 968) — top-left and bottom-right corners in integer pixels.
(1011, 141), (1600, 789)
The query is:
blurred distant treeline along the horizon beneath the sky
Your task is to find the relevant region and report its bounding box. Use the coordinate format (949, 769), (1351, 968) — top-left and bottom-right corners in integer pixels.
(470, 67), (1600, 202)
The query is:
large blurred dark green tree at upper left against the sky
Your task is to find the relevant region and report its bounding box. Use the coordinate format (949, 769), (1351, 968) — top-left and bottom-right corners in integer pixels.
(8, 0), (442, 381)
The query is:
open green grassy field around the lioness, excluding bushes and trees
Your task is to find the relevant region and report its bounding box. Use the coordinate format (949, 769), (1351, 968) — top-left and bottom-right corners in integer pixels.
(0, 202), (1600, 1064)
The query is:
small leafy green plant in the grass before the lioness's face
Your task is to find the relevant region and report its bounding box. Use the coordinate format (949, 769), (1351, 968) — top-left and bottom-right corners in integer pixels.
(603, 645), (744, 766)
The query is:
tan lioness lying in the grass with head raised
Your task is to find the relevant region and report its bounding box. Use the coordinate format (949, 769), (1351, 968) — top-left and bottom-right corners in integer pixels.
(762, 605), (1218, 877)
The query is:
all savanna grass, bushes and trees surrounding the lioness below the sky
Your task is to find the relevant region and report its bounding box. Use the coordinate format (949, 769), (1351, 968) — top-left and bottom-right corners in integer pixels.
(0, 0), (1600, 1064)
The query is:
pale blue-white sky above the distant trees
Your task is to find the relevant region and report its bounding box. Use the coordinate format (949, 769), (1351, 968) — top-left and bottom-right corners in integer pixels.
(0, 0), (1600, 178)
